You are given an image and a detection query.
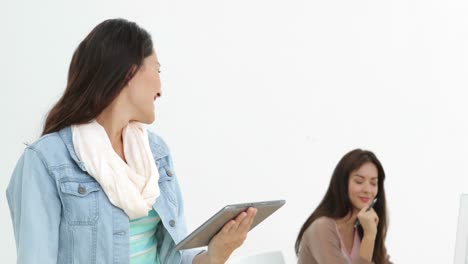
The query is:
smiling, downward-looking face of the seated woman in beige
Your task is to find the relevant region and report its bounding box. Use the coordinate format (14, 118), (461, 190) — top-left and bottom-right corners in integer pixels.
(348, 162), (378, 210)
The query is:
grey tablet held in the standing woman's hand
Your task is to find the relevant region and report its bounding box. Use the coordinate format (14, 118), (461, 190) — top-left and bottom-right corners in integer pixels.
(176, 200), (286, 250)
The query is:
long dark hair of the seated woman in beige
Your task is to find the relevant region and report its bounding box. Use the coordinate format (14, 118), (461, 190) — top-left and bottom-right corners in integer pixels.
(295, 149), (388, 264)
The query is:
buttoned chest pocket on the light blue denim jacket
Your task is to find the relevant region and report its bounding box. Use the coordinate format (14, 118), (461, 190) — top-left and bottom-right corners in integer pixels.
(60, 180), (101, 225)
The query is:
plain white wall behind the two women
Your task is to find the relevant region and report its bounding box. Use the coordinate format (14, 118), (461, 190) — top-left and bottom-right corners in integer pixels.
(0, 0), (468, 263)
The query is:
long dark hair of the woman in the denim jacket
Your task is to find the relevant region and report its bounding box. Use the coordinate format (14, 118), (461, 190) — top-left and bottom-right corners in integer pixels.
(42, 19), (154, 135)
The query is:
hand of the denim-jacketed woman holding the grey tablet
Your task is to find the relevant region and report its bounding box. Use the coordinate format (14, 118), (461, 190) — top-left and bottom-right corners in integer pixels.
(207, 207), (257, 264)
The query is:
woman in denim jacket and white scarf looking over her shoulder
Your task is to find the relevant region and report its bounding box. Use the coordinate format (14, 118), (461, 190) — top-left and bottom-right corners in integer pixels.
(7, 19), (256, 264)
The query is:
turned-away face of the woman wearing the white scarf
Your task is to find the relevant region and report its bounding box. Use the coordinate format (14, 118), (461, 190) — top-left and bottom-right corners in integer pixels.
(126, 53), (161, 124)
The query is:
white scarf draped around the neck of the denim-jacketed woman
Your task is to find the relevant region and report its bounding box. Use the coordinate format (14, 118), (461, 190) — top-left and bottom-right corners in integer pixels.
(71, 120), (159, 219)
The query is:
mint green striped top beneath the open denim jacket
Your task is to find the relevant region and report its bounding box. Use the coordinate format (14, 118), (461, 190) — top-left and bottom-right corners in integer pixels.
(130, 209), (161, 264)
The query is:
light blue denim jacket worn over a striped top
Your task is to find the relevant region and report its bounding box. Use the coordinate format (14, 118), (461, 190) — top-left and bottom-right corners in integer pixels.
(6, 127), (199, 264)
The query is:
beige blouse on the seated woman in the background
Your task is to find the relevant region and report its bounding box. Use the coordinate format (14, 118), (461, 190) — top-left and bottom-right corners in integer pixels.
(297, 217), (390, 264)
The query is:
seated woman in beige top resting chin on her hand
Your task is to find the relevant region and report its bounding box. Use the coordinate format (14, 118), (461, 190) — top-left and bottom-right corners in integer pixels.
(295, 149), (391, 264)
